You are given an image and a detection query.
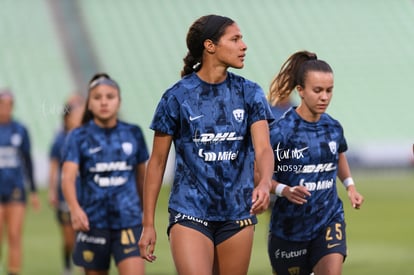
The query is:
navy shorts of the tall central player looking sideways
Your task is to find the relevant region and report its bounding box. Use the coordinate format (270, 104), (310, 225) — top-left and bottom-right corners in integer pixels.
(167, 209), (257, 246)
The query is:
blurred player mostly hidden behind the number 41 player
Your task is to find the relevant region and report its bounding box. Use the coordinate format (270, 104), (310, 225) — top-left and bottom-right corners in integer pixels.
(49, 94), (84, 275)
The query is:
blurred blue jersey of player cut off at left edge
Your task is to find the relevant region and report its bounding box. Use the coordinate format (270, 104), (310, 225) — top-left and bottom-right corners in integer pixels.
(0, 121), (36, 195)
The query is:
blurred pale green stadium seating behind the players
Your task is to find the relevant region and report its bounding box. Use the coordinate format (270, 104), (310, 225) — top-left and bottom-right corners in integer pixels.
(0, 0), (414, 187)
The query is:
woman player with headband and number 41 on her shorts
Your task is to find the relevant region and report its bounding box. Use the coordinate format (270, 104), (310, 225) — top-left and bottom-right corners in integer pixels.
(62, 74), (148, 275)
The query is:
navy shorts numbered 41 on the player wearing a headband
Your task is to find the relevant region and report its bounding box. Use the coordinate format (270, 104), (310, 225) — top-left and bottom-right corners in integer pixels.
(73, 226), (142, 270)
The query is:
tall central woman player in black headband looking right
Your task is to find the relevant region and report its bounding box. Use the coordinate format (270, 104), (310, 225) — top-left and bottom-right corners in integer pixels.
(140, 15), (273, 275)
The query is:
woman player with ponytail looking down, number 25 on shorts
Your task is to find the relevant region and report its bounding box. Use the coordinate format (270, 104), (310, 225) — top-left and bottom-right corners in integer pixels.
(268, 51), (363, 275)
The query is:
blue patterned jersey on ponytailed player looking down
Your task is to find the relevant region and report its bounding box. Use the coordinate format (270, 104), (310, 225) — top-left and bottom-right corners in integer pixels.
(270, 108), (347, 241)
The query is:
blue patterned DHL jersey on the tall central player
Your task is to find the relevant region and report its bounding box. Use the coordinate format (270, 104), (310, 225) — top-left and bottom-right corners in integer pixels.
(150, 72), (273, 221)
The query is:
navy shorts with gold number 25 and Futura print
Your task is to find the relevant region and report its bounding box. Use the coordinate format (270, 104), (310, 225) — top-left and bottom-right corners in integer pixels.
(268, 222), (346, 275)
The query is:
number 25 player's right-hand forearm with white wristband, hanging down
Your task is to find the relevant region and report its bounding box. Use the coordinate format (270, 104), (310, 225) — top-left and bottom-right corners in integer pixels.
(338, 152), (364, 209)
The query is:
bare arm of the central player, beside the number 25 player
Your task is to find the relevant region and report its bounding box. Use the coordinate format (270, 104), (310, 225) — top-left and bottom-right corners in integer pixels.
(251, 120), (274, 214)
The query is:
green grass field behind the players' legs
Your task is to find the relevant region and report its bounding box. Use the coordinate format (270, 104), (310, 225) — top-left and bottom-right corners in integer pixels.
(1, 171), (414, 275)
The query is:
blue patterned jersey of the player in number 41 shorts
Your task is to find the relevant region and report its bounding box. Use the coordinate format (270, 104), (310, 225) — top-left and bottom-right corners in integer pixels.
(63, 120), (148, 229)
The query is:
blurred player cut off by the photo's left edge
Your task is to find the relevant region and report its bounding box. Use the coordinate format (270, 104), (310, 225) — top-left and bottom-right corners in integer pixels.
(0, 89), (40, 275)
